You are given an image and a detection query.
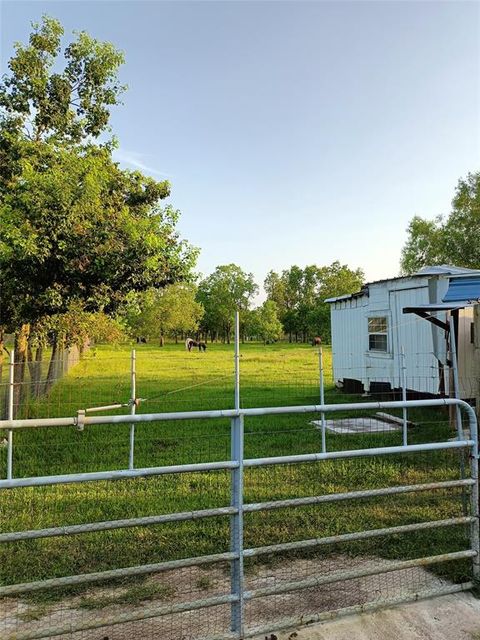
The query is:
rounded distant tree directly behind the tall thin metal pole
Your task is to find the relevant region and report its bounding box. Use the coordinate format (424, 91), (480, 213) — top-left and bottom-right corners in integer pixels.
(198, 264), (258, 343)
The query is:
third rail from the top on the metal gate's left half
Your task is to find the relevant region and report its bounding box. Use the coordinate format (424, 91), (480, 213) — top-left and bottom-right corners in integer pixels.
(0, 507), (236, 543)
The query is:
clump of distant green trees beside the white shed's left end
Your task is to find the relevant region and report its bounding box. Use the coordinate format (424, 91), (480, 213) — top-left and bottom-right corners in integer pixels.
(264, 261), (364, 341)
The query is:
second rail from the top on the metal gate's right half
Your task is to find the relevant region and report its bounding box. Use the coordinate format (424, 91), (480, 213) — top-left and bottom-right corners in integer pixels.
(244, 440), (474, 468)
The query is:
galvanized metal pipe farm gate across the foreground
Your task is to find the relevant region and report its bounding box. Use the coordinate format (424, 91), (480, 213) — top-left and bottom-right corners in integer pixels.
(0, 399), (480, 640)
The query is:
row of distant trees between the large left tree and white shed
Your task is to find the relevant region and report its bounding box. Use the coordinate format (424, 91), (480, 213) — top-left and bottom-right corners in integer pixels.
(120, 262), (364, 344)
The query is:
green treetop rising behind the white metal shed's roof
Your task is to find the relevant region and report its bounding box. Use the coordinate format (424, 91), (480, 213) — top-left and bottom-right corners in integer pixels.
(401, 172), (480, 274)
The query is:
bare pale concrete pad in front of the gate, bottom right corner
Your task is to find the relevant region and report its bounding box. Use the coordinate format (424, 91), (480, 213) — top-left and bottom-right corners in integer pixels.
(258, 593), (480, 640)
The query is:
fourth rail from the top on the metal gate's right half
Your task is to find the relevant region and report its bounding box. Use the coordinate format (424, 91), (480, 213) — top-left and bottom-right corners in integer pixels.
(243, 516), (475, 558)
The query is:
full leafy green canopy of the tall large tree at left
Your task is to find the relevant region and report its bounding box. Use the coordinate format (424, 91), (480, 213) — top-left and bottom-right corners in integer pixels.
(0, 17), (197, 400)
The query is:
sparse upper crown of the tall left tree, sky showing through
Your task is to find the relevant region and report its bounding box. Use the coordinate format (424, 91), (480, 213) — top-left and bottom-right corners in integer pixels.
(0, 16), (125, 143)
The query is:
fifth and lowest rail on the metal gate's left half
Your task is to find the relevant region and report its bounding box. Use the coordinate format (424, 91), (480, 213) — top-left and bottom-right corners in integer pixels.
(4, 595), (235, 640)
